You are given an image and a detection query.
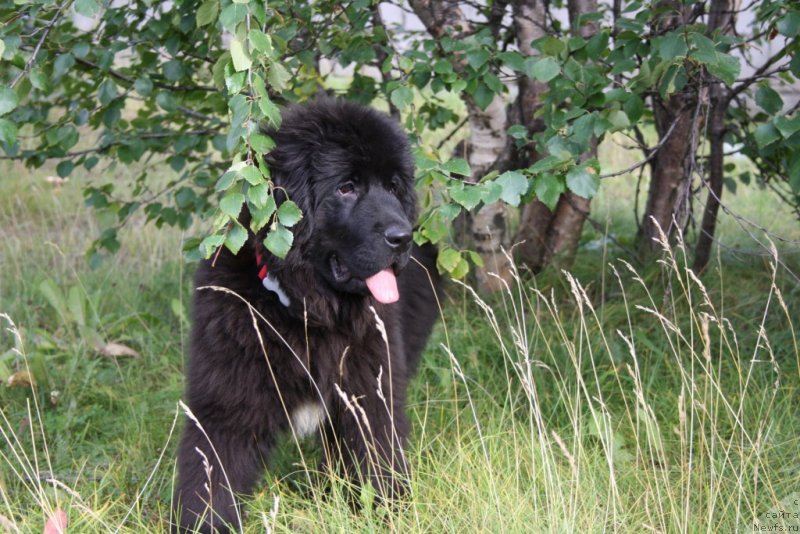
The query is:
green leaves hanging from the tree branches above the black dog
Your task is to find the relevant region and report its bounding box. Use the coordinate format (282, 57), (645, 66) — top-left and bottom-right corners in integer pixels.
(0, 0), (800, 276)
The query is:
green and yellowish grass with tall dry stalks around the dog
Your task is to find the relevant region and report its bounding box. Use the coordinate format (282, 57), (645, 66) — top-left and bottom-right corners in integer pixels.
(0, 157), (800, 533)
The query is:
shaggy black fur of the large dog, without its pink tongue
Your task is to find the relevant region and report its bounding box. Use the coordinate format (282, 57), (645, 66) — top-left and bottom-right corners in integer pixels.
(174, 100), (438, 532)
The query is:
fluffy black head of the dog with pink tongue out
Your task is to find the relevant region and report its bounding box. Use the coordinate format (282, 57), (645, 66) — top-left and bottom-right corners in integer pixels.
(267, 100), (417, 303)
